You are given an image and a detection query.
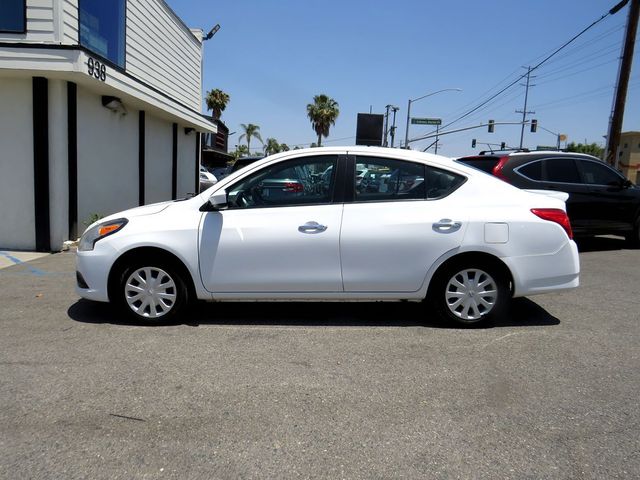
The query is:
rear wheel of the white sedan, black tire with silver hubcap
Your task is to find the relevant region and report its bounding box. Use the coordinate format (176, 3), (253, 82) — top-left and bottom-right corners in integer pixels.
(430, 260), (511, 327)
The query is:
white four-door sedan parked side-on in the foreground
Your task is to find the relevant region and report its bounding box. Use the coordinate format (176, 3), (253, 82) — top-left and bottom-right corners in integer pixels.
(77, 147), (580, 325)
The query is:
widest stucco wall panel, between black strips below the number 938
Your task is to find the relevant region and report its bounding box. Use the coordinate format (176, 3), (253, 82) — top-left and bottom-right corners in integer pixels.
(78, 87), (138, 227)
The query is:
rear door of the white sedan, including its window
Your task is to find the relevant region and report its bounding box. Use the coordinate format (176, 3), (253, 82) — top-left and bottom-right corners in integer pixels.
(340, 156), (467, 293)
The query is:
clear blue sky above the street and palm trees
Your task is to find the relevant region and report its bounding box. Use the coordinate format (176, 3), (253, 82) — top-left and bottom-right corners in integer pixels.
(168, 0), (640, 156)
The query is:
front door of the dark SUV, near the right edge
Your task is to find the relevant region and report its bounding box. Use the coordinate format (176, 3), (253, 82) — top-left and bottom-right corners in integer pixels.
(576, 159), (639, 232)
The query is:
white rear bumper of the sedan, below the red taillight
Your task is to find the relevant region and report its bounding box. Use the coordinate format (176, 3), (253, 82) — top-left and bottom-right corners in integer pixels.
(502, 240), (580, 297)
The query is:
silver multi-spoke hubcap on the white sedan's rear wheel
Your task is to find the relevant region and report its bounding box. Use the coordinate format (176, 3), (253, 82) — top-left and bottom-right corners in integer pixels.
(445, 269), (498, 322)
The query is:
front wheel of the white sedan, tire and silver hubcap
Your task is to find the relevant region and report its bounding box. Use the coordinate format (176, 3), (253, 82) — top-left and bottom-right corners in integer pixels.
(115, 259), (189, 325)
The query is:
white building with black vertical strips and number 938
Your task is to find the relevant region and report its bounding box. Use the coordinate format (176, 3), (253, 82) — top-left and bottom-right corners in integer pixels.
(0, 0), (216, 251)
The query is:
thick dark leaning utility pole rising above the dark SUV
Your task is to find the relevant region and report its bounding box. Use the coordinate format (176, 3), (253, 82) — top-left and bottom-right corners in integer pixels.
(604, 0), (640, 166)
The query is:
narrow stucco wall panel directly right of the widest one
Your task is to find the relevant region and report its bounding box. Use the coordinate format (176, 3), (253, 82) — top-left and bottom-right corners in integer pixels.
(144, 115), (173, 204)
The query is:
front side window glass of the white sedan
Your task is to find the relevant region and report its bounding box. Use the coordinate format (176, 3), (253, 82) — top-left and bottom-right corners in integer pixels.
(228, 155), (337, 208)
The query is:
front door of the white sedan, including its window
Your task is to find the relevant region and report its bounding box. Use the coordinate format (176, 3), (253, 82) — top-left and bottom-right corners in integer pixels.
(199, 155), (342, 296)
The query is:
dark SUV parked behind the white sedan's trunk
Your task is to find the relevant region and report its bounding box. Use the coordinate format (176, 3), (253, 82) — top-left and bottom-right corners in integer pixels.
(457, 152), (640, 247)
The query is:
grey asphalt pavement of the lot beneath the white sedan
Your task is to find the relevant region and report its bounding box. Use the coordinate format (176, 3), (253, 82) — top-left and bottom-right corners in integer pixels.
(0, 238), (640, 479)
